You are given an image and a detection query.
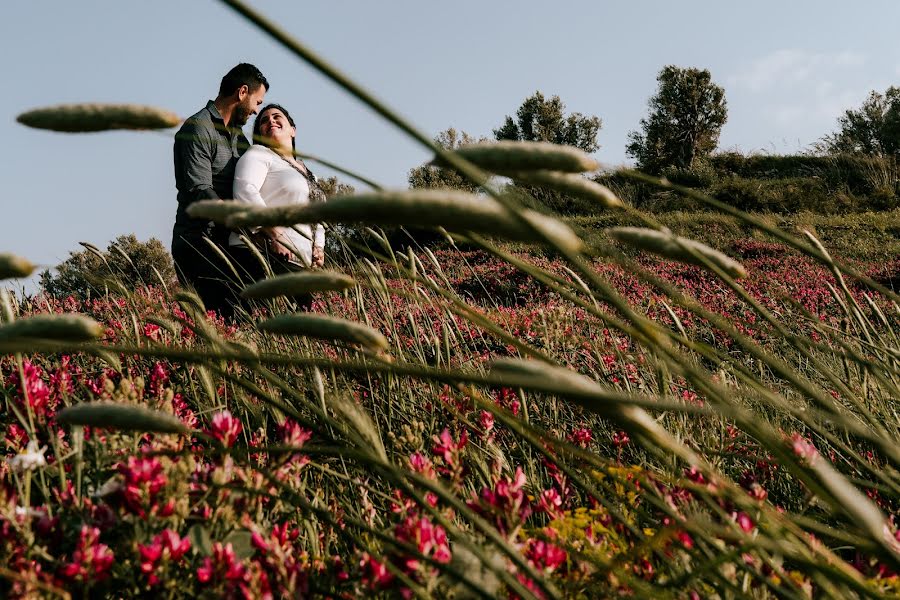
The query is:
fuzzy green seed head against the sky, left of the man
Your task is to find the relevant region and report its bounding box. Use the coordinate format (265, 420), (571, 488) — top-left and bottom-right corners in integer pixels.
(16, 103), (181, 133)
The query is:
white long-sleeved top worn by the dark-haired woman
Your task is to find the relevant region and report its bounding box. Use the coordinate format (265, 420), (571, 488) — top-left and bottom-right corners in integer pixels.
(229, 144), (325, 265)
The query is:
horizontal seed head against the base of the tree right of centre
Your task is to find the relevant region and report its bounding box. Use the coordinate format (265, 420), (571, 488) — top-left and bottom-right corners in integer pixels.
(432, 140), (600, 175)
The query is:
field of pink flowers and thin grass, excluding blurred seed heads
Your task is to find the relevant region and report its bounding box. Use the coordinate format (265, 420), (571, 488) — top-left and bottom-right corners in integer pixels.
(0, 231), (900, 598)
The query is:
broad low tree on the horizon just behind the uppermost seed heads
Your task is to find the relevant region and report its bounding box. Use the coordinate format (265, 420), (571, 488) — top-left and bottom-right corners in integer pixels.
(494, 91), (603, 154)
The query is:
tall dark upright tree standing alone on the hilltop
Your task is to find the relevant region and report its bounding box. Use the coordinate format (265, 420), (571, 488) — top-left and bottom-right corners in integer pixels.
(626, 65), (728, 173)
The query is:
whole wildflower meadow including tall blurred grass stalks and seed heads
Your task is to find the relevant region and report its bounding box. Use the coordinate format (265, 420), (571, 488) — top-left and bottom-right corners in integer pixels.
(0, 1), (900, 599)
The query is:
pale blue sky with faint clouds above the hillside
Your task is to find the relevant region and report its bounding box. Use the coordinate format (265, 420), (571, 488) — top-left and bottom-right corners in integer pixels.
(0, 0), (900, 290)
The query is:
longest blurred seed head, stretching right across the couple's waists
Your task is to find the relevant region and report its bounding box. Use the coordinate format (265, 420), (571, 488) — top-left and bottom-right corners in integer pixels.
(226, 189), (583, 252)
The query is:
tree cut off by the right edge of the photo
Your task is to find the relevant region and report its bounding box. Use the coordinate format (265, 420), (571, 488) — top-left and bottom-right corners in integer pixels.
(816, 86), (900, 157)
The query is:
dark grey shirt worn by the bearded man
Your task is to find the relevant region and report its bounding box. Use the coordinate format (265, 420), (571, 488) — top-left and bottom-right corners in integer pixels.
(172, 100), (250, 245)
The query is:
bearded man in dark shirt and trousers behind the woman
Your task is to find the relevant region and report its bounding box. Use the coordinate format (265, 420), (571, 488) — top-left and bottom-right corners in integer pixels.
(172, 63), (269, 320)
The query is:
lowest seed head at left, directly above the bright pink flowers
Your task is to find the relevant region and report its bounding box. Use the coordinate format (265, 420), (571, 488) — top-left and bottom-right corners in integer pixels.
(56, 402), (190, 434)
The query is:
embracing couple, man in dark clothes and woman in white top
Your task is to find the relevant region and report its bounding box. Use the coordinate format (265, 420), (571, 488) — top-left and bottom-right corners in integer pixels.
(172, 63), (325, 320)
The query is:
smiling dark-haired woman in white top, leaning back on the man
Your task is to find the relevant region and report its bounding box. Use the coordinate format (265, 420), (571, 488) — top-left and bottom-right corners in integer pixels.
(229, 104), (325, 280)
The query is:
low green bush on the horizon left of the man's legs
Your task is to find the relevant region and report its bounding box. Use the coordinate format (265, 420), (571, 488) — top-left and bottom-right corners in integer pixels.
(40, 234), (175, 299)
